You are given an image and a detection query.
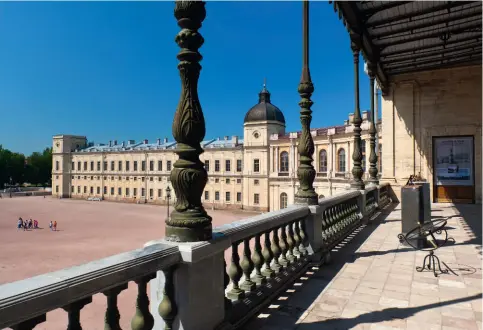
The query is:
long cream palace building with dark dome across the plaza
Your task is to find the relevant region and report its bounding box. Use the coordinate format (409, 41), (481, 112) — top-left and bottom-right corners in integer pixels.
(52, 86), (382, 211)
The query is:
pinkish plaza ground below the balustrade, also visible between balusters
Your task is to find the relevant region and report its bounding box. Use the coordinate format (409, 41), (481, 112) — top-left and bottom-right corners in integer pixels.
(0, 197), (260, 330)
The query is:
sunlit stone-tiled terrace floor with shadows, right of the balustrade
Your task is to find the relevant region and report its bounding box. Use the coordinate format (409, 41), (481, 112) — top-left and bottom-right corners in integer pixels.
(245, 204), (482, 330)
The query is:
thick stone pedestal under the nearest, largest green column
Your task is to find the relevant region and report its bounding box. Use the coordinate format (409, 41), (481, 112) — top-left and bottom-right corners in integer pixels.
(145, 240), (229, 330)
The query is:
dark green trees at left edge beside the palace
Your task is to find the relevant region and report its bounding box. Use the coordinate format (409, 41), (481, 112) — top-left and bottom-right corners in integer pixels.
(0, 145), (52, 188)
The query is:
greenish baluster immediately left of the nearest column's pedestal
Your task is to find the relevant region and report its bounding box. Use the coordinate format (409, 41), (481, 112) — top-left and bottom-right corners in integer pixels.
(131, 274), (156, 330)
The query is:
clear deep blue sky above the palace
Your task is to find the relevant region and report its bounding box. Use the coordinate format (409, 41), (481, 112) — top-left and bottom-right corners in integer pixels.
(0, 2), (369, 154)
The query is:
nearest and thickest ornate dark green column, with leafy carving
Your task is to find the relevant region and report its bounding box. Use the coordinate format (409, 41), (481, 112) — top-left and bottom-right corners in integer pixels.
(166, 1), (212, 242)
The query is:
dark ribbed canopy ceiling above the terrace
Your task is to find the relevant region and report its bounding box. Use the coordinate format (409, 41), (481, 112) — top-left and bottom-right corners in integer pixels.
(333, 1), (482, 91)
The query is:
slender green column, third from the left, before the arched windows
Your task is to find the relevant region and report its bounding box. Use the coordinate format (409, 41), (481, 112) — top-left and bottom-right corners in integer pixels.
(351, 35), (365, 190)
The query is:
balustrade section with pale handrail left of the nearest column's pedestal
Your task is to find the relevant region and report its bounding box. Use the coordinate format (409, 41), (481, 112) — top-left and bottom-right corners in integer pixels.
(0, 244), (180, 329)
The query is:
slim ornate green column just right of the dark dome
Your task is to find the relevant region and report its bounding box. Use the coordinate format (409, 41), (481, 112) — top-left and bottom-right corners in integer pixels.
(295, 0), (318, 205)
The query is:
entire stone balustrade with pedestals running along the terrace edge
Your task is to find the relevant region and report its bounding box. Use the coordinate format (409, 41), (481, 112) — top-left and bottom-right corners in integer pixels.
(0, 184), (391, 330)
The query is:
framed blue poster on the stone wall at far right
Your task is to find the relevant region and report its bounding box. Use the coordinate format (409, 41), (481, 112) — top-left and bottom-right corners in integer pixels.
(433, 136), (474, 186)
